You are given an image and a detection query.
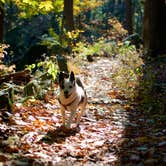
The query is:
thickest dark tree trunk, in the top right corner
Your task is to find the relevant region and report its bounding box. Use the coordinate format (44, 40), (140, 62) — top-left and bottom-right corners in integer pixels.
(143, 0), (166, 56)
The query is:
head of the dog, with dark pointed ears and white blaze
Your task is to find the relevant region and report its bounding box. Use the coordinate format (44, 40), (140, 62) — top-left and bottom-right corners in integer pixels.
(59, 71), (76, 98)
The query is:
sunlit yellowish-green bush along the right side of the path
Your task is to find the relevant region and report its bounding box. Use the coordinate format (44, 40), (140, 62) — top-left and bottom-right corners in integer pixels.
(113, 43), (143, 99)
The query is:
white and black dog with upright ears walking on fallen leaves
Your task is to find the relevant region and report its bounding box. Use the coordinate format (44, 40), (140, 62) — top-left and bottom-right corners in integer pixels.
(58, 71), (87, 128)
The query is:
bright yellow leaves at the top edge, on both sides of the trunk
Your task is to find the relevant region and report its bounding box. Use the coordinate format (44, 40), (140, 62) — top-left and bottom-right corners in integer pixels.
(12, 0), (104, 17)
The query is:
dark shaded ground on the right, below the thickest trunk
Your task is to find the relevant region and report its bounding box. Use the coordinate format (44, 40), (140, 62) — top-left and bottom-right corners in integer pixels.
(120, 56), (166, 166)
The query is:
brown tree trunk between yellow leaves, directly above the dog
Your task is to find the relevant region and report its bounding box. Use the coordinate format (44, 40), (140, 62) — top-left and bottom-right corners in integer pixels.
(63, 0), (74, 31)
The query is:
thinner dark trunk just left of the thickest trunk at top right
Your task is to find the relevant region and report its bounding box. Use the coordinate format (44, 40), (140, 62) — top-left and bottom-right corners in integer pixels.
(125, 0), (133, 35)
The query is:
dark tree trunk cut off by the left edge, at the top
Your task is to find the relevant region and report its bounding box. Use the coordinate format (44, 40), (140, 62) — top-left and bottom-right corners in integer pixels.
(0, 2), (4, 43)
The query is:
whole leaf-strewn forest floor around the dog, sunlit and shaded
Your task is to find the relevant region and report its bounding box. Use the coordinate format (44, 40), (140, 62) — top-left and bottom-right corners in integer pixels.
(0, 55), (166, 166)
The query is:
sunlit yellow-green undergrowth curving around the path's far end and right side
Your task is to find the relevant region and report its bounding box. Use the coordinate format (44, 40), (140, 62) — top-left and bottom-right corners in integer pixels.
(73, 38), (143, 100)
